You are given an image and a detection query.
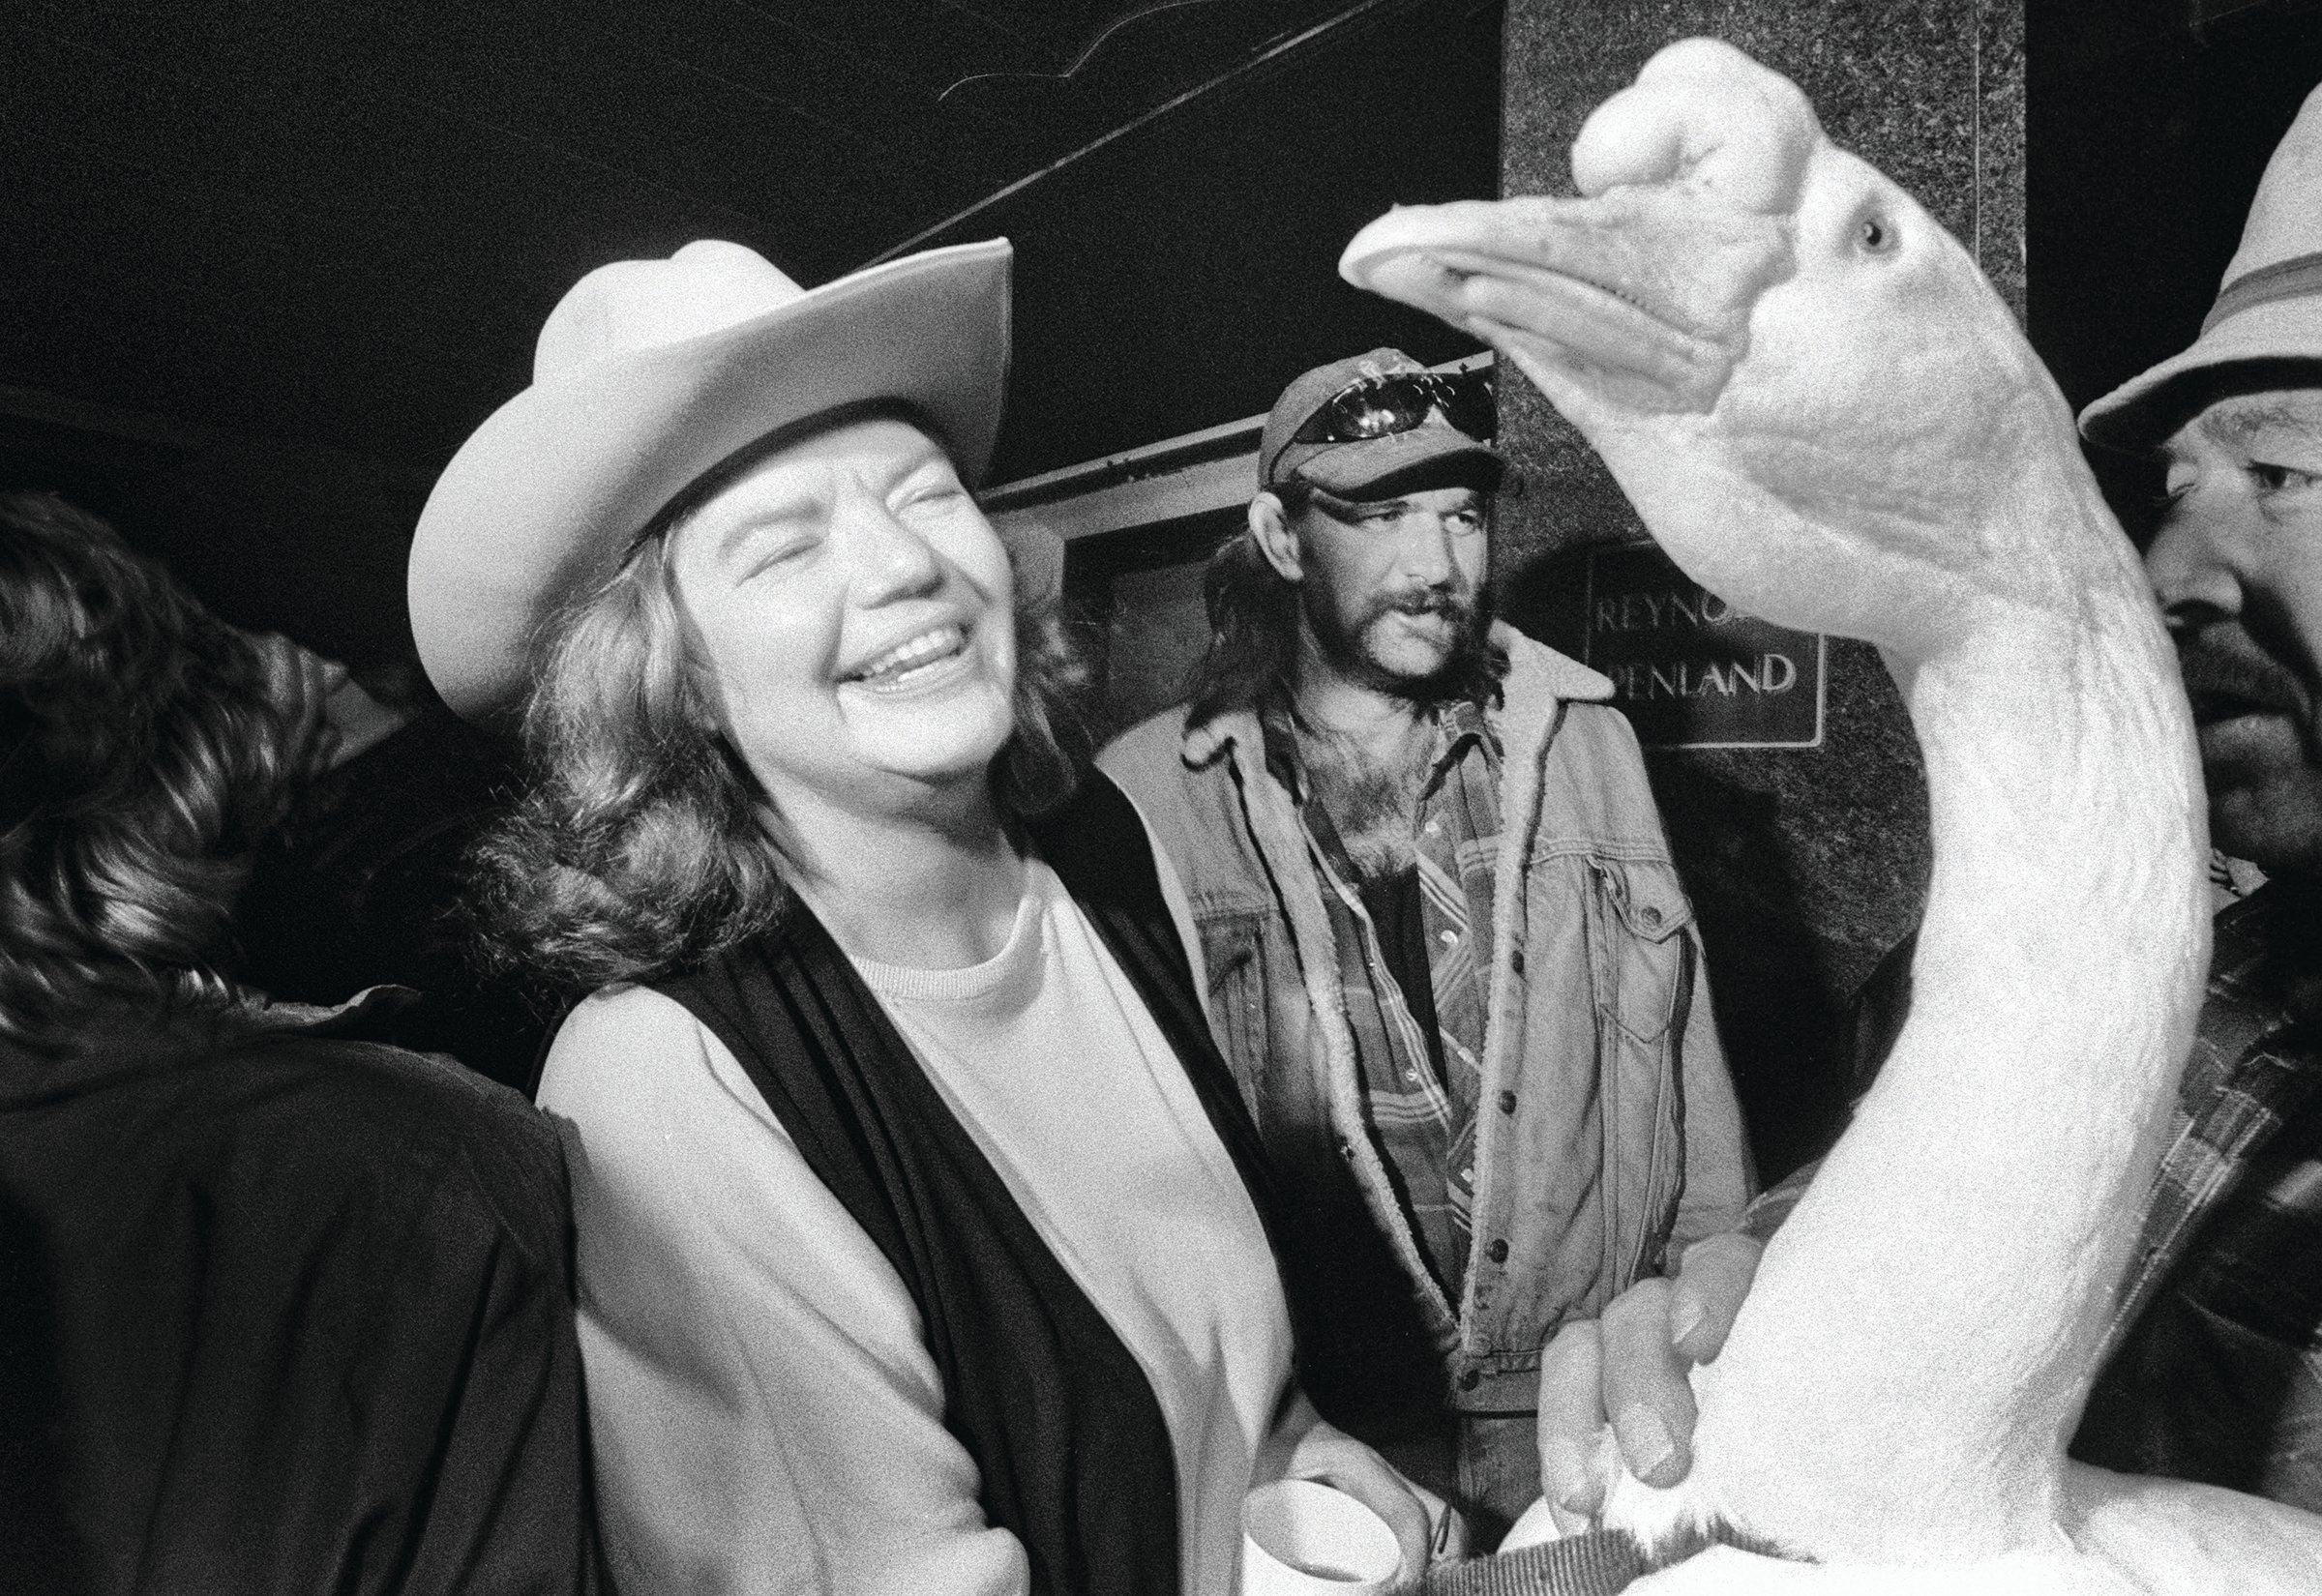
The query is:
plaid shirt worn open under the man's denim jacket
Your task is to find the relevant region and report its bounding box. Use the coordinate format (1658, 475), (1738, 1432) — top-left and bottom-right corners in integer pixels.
(1261, 703), (1500, 1304)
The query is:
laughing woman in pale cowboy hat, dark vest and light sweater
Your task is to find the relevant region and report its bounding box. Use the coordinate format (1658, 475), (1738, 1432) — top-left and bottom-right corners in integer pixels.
(411, 244), (1428, 1596)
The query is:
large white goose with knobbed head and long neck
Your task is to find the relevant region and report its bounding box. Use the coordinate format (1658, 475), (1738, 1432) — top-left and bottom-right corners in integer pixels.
(1340, 40), (2322, 1596)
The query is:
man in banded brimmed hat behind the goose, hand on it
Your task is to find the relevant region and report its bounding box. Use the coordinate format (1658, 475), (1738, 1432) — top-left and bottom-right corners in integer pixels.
(1542, 74), (2322, 1513)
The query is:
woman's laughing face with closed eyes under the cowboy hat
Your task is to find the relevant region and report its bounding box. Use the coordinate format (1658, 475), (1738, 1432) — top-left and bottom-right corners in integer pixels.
(669, 418), (1015, 830)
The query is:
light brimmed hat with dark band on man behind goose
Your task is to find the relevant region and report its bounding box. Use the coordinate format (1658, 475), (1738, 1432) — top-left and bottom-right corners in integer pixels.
(2080, 88), (2322, 448)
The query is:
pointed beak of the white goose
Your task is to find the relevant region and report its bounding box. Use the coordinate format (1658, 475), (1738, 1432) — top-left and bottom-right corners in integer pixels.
(1337, 183), (1790, 410)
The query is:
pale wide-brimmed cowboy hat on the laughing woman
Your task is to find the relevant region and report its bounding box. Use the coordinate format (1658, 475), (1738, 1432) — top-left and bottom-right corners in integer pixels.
(408, 239), (1010, 719)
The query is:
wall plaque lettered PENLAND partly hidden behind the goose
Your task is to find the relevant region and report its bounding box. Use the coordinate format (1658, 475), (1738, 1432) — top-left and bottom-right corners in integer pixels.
(1581, 543), (1828, 747)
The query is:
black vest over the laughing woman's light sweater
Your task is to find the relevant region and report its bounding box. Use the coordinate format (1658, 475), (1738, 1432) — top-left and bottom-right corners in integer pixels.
(655, 773), (1279, 1596)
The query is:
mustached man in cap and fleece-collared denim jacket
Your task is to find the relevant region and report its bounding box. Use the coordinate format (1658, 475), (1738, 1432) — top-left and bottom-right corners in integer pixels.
(1101, 350), (1751, 1536)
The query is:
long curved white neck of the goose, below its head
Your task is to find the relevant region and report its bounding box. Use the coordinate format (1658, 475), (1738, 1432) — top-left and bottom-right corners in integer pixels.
(1702, 551), (2208, 1561)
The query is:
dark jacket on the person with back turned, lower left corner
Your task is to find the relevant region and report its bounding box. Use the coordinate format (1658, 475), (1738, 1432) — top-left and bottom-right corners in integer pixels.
(0, 992), (597, 1596)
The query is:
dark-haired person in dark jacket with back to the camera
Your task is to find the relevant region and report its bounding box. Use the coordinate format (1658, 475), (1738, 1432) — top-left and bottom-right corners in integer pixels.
(0, 494), (597, 1596)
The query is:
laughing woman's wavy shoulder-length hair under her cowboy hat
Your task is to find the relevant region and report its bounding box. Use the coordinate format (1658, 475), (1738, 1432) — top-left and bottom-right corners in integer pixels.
(476, 458), (1087, 990)
